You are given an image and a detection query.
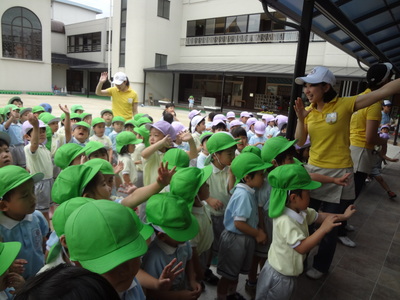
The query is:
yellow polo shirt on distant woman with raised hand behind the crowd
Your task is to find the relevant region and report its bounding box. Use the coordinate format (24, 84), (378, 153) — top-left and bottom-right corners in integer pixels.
(107, 87), (138, 120)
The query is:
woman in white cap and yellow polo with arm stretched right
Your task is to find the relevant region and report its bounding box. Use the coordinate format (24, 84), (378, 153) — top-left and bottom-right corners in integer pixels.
(294, 67), (400, 279)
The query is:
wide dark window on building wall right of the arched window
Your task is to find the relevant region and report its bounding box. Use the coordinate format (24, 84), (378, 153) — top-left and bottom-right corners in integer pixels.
(67, 31), (101, 53)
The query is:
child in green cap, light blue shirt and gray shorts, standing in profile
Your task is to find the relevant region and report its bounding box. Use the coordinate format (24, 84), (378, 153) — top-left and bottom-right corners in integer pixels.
(217, 153), (271, 300)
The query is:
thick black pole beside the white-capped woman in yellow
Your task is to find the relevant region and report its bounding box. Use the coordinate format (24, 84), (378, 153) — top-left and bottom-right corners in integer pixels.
(286, 0), (314, 140)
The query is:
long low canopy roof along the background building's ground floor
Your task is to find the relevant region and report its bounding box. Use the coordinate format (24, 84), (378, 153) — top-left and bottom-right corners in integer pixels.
(144, 63), (366, 80)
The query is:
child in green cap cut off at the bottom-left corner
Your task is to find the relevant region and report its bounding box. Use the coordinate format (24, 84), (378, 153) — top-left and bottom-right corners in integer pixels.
(0, 242), (25, 300)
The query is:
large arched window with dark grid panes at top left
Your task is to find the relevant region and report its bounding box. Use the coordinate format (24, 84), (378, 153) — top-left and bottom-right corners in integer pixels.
(1, 6), (42, 60)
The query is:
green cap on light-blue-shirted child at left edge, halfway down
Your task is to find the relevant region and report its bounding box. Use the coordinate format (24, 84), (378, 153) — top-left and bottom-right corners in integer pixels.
(0, 165), (44, 198)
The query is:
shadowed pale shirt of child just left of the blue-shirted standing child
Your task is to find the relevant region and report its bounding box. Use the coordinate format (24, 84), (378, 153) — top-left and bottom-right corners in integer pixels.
(190, 205), (214, 256)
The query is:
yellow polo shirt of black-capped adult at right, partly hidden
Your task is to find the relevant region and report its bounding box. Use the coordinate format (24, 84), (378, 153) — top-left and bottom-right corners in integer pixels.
(350, 89), (382, 150)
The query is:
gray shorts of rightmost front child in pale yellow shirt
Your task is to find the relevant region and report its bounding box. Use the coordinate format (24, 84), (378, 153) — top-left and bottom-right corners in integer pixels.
(256, 261), (297, 300)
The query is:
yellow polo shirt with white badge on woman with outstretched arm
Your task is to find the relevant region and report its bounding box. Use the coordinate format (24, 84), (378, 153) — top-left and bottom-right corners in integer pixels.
(304, 96), (357, 169)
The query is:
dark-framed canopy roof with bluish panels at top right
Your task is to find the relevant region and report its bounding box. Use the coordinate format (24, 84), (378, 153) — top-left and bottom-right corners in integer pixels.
(262, 0), (400, 74)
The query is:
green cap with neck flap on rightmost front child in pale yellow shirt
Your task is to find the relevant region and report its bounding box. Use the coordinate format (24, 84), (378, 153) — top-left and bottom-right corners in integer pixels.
(268, 164), (321, 218)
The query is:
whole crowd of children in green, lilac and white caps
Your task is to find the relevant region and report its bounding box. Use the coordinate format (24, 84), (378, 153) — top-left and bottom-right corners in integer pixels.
(0, 96), (396, 300)
